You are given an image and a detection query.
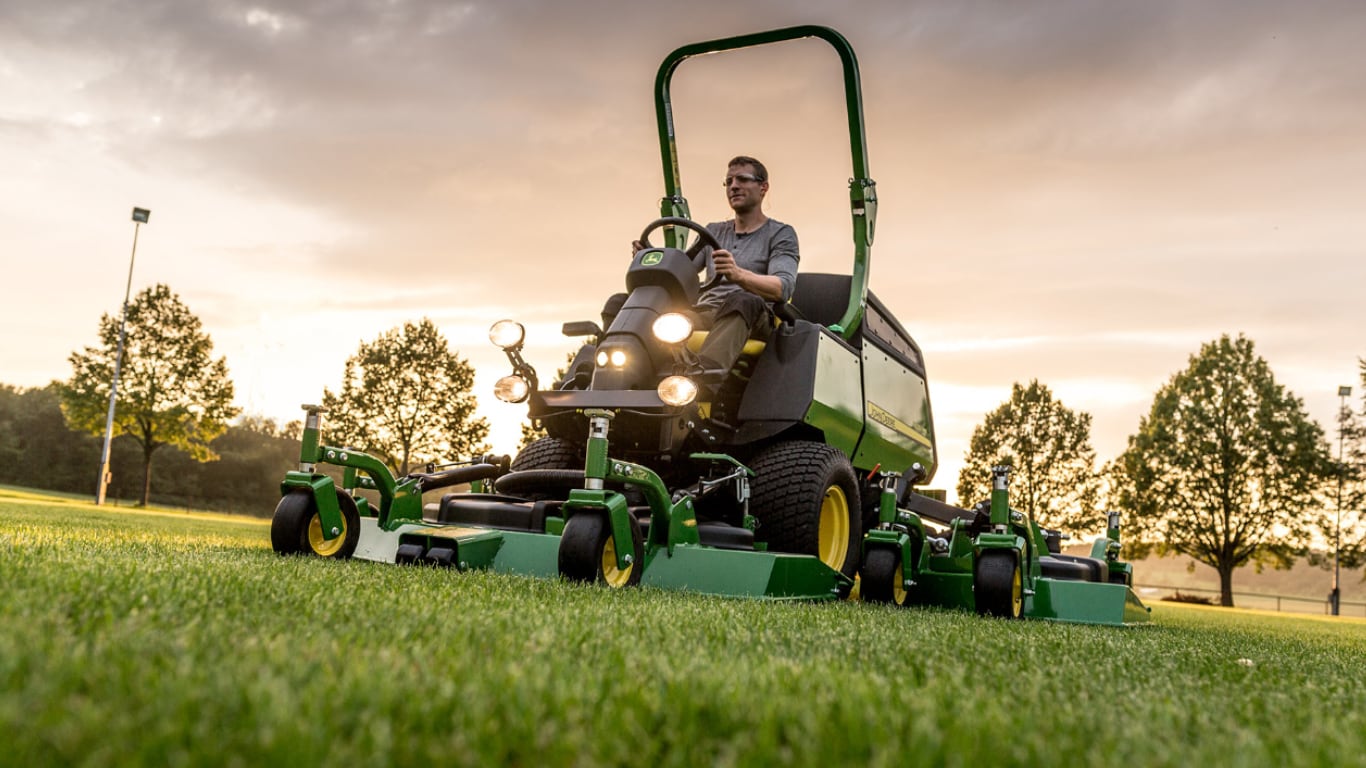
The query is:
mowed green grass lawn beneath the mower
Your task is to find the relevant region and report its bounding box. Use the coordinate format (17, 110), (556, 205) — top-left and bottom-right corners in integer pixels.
(0, 497), (1366, 767)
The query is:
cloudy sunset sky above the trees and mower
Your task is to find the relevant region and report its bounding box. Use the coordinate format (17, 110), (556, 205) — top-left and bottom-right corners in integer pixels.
(0, 0), (1366, 500)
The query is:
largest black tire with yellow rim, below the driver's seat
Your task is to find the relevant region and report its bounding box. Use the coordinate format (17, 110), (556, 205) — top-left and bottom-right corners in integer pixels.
(750, 440), (863, 579)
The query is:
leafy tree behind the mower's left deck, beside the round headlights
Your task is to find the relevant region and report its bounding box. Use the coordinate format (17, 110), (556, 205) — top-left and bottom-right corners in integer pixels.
(322, 317), (489, 474)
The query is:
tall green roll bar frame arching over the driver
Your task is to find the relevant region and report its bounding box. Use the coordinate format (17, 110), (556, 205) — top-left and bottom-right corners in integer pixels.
(654, 25), (877, 340)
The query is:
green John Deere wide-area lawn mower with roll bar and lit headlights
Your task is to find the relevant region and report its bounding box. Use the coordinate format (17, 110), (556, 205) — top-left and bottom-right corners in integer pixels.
(263, 26), (1146, 623)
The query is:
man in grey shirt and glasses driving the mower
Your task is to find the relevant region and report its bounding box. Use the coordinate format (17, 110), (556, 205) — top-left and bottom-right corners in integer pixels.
(632, 154), (800, 370)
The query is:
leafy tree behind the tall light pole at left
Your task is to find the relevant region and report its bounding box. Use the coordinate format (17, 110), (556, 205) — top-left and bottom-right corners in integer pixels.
(61, 284), (238, 506)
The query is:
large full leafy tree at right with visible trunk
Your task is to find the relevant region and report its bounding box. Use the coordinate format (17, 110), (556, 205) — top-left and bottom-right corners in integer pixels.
(1112, 335), (1332, 605)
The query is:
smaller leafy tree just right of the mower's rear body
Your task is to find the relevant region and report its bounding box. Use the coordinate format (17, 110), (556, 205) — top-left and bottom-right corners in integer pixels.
(958, 379), (1105, 534)
